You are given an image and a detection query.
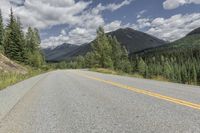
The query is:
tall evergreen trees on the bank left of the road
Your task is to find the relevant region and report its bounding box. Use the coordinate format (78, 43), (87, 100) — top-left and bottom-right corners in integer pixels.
(0, 8), (44, 67)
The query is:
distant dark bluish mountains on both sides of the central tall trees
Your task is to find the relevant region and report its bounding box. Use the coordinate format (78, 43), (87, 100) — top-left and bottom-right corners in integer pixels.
(44, 28), (166, 62)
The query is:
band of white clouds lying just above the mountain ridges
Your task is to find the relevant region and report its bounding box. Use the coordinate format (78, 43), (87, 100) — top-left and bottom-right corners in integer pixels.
(41, 10), (200, 46)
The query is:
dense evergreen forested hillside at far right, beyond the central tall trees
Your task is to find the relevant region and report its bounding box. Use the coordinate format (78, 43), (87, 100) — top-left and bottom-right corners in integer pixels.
(131, 32), (200, 84)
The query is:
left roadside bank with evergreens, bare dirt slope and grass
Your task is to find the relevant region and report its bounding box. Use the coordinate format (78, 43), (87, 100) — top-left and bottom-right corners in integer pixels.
(0, 9), (49, 89)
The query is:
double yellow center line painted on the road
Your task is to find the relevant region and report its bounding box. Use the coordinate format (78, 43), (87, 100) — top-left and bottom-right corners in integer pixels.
(77, 72), (200, 110)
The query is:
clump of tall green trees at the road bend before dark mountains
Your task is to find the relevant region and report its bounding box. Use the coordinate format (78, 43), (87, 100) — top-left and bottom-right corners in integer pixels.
(56, 27), (132, 73)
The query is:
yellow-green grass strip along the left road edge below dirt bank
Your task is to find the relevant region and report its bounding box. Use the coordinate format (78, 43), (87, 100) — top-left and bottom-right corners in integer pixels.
(0, 69), (44, 90)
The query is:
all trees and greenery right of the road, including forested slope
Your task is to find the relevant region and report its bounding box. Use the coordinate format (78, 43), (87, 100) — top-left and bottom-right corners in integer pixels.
(52, 27), (200, 85)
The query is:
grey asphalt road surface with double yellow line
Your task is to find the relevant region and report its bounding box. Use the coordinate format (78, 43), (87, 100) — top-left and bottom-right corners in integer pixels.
(0, 70), (200, 133)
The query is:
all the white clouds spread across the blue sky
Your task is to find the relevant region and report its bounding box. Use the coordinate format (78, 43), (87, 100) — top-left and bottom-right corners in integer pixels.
(0, 0), (200, 47)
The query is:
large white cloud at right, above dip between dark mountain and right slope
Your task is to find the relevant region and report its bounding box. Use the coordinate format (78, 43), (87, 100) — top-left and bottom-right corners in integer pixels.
(146, 13), (200, 41)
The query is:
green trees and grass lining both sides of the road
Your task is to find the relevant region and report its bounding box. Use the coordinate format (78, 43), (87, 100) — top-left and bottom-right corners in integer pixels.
(0, 9), (200, 88)
